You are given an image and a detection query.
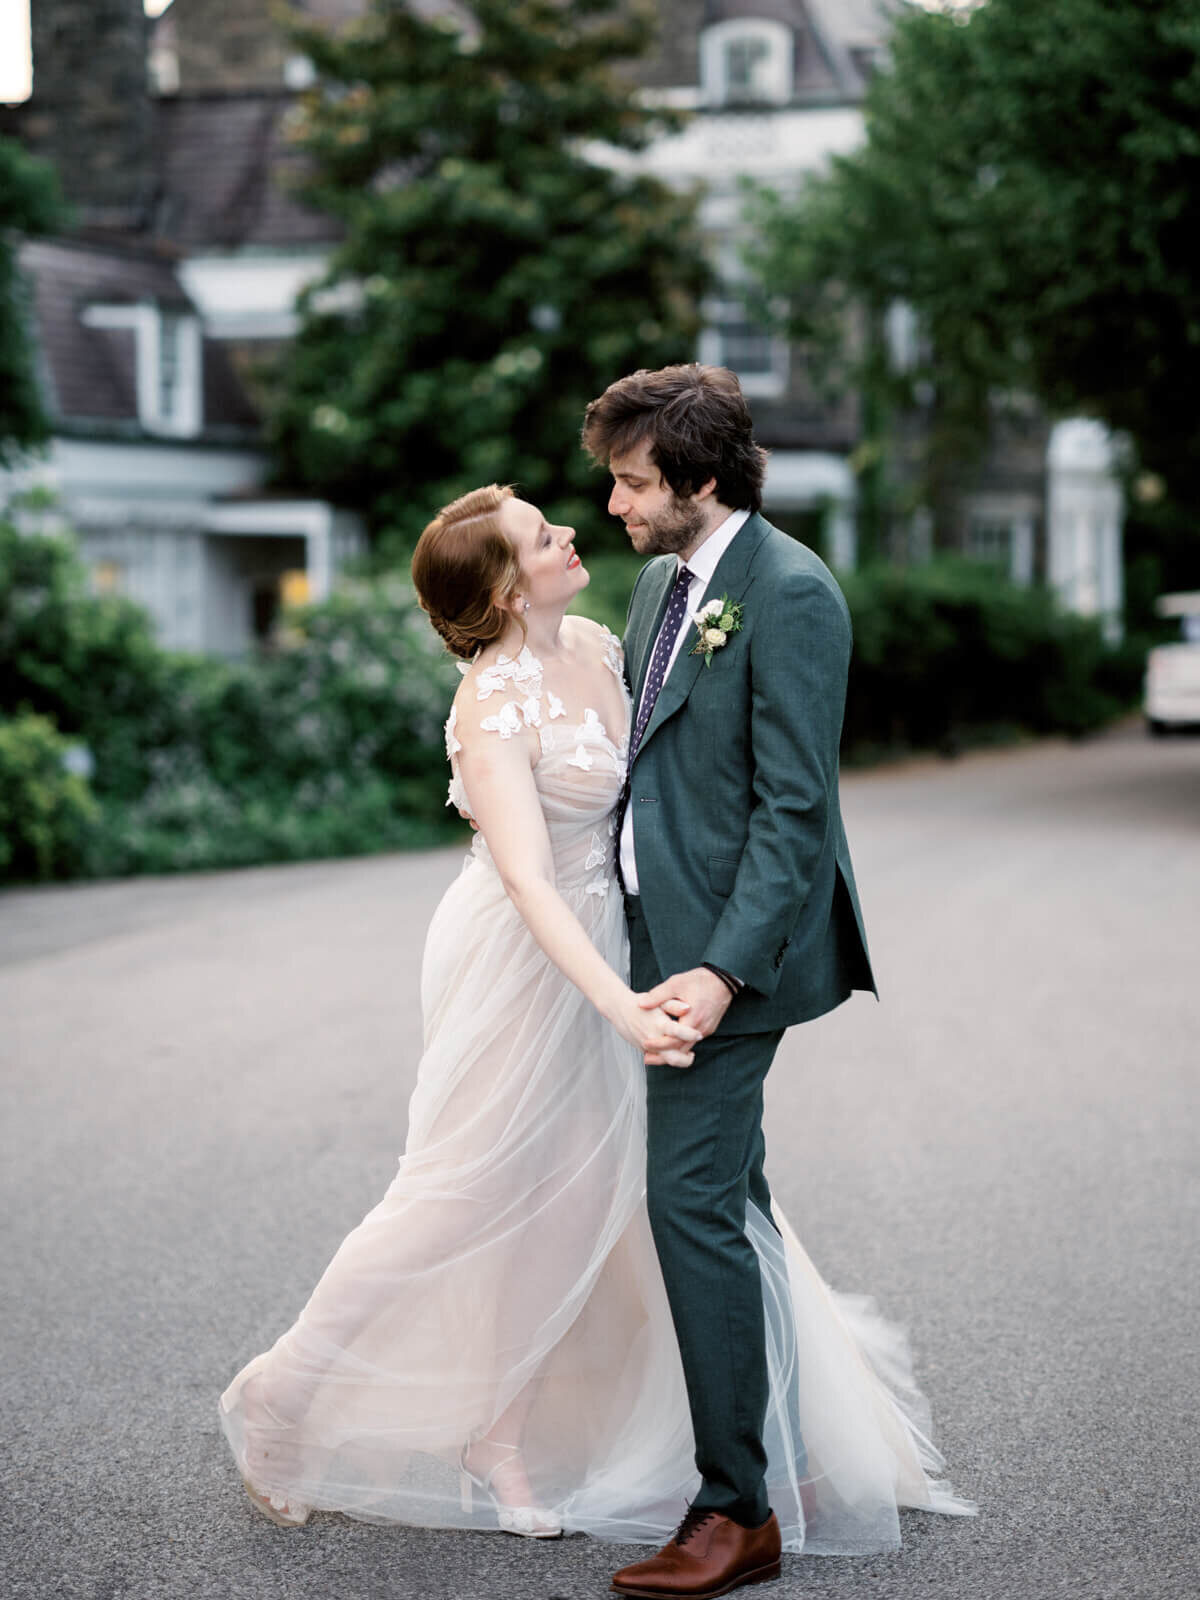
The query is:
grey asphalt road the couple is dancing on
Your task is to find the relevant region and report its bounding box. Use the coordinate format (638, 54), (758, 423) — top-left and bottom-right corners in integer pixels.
(0, 728), (1200, 1600)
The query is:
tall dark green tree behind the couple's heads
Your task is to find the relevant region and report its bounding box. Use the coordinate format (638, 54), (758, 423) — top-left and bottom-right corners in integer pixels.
(274, 0), (707, 542)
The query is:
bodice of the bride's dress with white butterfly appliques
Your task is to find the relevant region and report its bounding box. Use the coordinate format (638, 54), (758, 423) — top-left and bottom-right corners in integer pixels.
(446, 629), (630, 896)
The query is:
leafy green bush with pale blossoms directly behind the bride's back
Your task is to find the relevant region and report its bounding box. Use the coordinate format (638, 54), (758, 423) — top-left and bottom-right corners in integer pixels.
(82, 578), (467, 872)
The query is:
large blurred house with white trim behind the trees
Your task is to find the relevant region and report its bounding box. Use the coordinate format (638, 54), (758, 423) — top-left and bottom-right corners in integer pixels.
(0, 0), (1122, 636)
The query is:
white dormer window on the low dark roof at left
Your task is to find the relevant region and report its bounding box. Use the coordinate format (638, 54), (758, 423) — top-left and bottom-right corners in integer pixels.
(80, 301), (203, 438)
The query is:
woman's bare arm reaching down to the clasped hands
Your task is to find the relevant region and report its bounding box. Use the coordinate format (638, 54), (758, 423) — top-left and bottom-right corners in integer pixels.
(458, 706), (701, 1066)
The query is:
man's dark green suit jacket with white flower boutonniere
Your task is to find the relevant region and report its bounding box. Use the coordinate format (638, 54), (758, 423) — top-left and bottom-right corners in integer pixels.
(626, 514), (875, 1034)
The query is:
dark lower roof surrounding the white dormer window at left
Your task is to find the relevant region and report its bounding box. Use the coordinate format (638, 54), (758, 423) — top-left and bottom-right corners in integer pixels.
(19, 238), (258, 430)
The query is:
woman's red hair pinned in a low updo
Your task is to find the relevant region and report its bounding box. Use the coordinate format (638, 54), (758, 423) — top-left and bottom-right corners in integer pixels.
(413, 483), (525, 661)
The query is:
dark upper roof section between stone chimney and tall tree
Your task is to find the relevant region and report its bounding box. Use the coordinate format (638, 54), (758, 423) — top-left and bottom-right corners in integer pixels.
(155, 90), (341, 250)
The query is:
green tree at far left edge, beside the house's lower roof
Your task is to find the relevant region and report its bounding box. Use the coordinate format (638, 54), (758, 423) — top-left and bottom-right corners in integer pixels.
(0, 139), (62, 467)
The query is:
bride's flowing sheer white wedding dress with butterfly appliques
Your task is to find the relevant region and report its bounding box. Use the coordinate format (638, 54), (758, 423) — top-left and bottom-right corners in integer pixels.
(221, 635), (971, 1554)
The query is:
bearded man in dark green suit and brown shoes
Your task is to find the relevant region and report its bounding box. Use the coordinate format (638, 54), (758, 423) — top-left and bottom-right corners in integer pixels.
(582, 365), (874, 1600)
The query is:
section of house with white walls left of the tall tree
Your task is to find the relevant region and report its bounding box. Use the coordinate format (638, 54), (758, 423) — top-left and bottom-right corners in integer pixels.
(0, 0), (366, 654)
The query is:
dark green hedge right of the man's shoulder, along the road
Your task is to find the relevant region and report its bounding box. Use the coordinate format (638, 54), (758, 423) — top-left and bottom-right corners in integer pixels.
(842, 558), (1142, 760)
